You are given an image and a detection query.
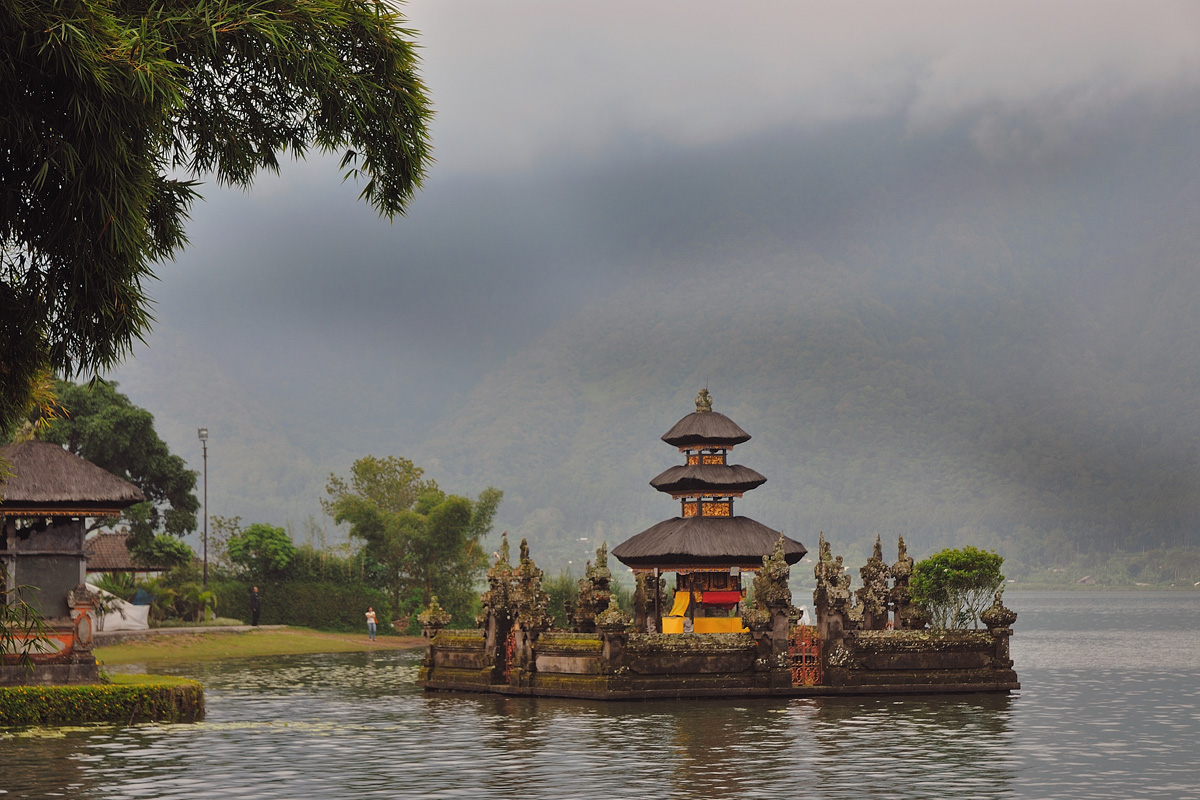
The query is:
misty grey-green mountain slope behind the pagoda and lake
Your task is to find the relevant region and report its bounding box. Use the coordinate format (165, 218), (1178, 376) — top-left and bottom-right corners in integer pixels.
(420, 112), (1200, 573)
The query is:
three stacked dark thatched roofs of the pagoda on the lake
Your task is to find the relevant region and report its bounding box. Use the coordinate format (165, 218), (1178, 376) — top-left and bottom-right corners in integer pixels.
(612, 390), (806, 571)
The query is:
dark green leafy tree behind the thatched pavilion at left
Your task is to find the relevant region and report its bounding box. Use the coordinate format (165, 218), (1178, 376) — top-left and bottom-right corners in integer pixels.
(38, 381), (200, 566)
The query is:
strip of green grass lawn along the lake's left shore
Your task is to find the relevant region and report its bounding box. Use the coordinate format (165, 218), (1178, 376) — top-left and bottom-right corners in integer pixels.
(94, 627), (422, 667)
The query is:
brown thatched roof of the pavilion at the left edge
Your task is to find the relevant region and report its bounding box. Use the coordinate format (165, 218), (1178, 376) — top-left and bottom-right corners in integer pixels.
(0, 441), (145, 517)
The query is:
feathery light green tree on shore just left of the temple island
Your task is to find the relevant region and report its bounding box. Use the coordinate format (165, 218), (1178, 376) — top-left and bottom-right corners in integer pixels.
(322, 456), (503, 619)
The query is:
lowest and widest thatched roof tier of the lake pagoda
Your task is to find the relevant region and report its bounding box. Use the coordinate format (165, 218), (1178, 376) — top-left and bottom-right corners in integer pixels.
(612, 517), (808, 570)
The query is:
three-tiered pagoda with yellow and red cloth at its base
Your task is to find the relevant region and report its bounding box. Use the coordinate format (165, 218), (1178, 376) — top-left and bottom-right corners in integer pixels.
(612, 389), (806, 633)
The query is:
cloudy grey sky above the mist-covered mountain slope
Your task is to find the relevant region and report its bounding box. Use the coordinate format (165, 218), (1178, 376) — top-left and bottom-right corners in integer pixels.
(115, 0), (1200, 525)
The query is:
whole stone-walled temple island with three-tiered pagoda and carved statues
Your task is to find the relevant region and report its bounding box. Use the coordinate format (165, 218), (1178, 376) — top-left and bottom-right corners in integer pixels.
(418, 390), (1020, 700)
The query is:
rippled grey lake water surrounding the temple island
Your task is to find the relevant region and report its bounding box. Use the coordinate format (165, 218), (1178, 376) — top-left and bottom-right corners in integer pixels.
(0, 591), (1200, 800)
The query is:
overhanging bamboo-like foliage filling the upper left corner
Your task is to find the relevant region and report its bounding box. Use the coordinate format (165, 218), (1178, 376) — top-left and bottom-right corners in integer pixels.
(0, 0), (432, 432)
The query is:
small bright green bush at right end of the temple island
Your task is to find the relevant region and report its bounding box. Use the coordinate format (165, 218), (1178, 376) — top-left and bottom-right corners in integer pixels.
(908, 547), (1004, 628)
